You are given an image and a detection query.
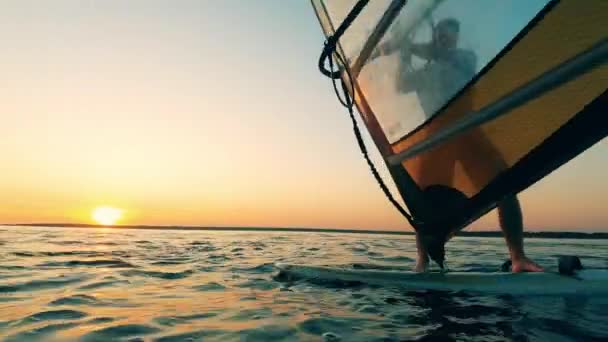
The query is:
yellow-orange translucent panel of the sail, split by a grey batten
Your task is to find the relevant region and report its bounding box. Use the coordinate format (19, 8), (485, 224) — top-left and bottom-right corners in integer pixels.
(393, 0), (608, 197)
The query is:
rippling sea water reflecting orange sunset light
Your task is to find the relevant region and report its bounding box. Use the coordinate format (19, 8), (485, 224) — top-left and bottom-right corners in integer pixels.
(0, 226), (608, 341)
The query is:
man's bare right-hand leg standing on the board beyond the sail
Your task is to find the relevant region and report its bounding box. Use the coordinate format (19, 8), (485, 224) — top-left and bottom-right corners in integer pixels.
(498, 196), (543, 272)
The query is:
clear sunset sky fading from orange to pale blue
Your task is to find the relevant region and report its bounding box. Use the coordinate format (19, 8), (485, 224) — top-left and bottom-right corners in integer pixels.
(0, 0), (608, 231)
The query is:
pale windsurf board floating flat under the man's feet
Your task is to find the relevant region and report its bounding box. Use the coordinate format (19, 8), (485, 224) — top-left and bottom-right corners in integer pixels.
(275, 263), (608, 295)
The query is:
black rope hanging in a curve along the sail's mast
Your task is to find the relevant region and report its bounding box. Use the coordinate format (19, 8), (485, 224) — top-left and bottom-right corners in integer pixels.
(319, 0), (414, 225)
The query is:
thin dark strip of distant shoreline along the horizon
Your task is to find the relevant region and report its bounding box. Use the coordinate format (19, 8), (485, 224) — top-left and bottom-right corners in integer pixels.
(3, 223), (608, 239)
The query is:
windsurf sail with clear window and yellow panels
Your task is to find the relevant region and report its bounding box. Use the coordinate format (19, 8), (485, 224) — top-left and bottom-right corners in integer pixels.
(312, 0), (608, 262)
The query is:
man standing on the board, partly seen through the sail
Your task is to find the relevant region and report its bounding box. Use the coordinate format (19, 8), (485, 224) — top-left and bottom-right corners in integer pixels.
(371, 18), (543, 272)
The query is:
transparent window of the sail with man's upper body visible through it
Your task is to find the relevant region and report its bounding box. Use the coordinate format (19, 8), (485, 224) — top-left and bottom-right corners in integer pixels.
(350, 0), (548, 143)
